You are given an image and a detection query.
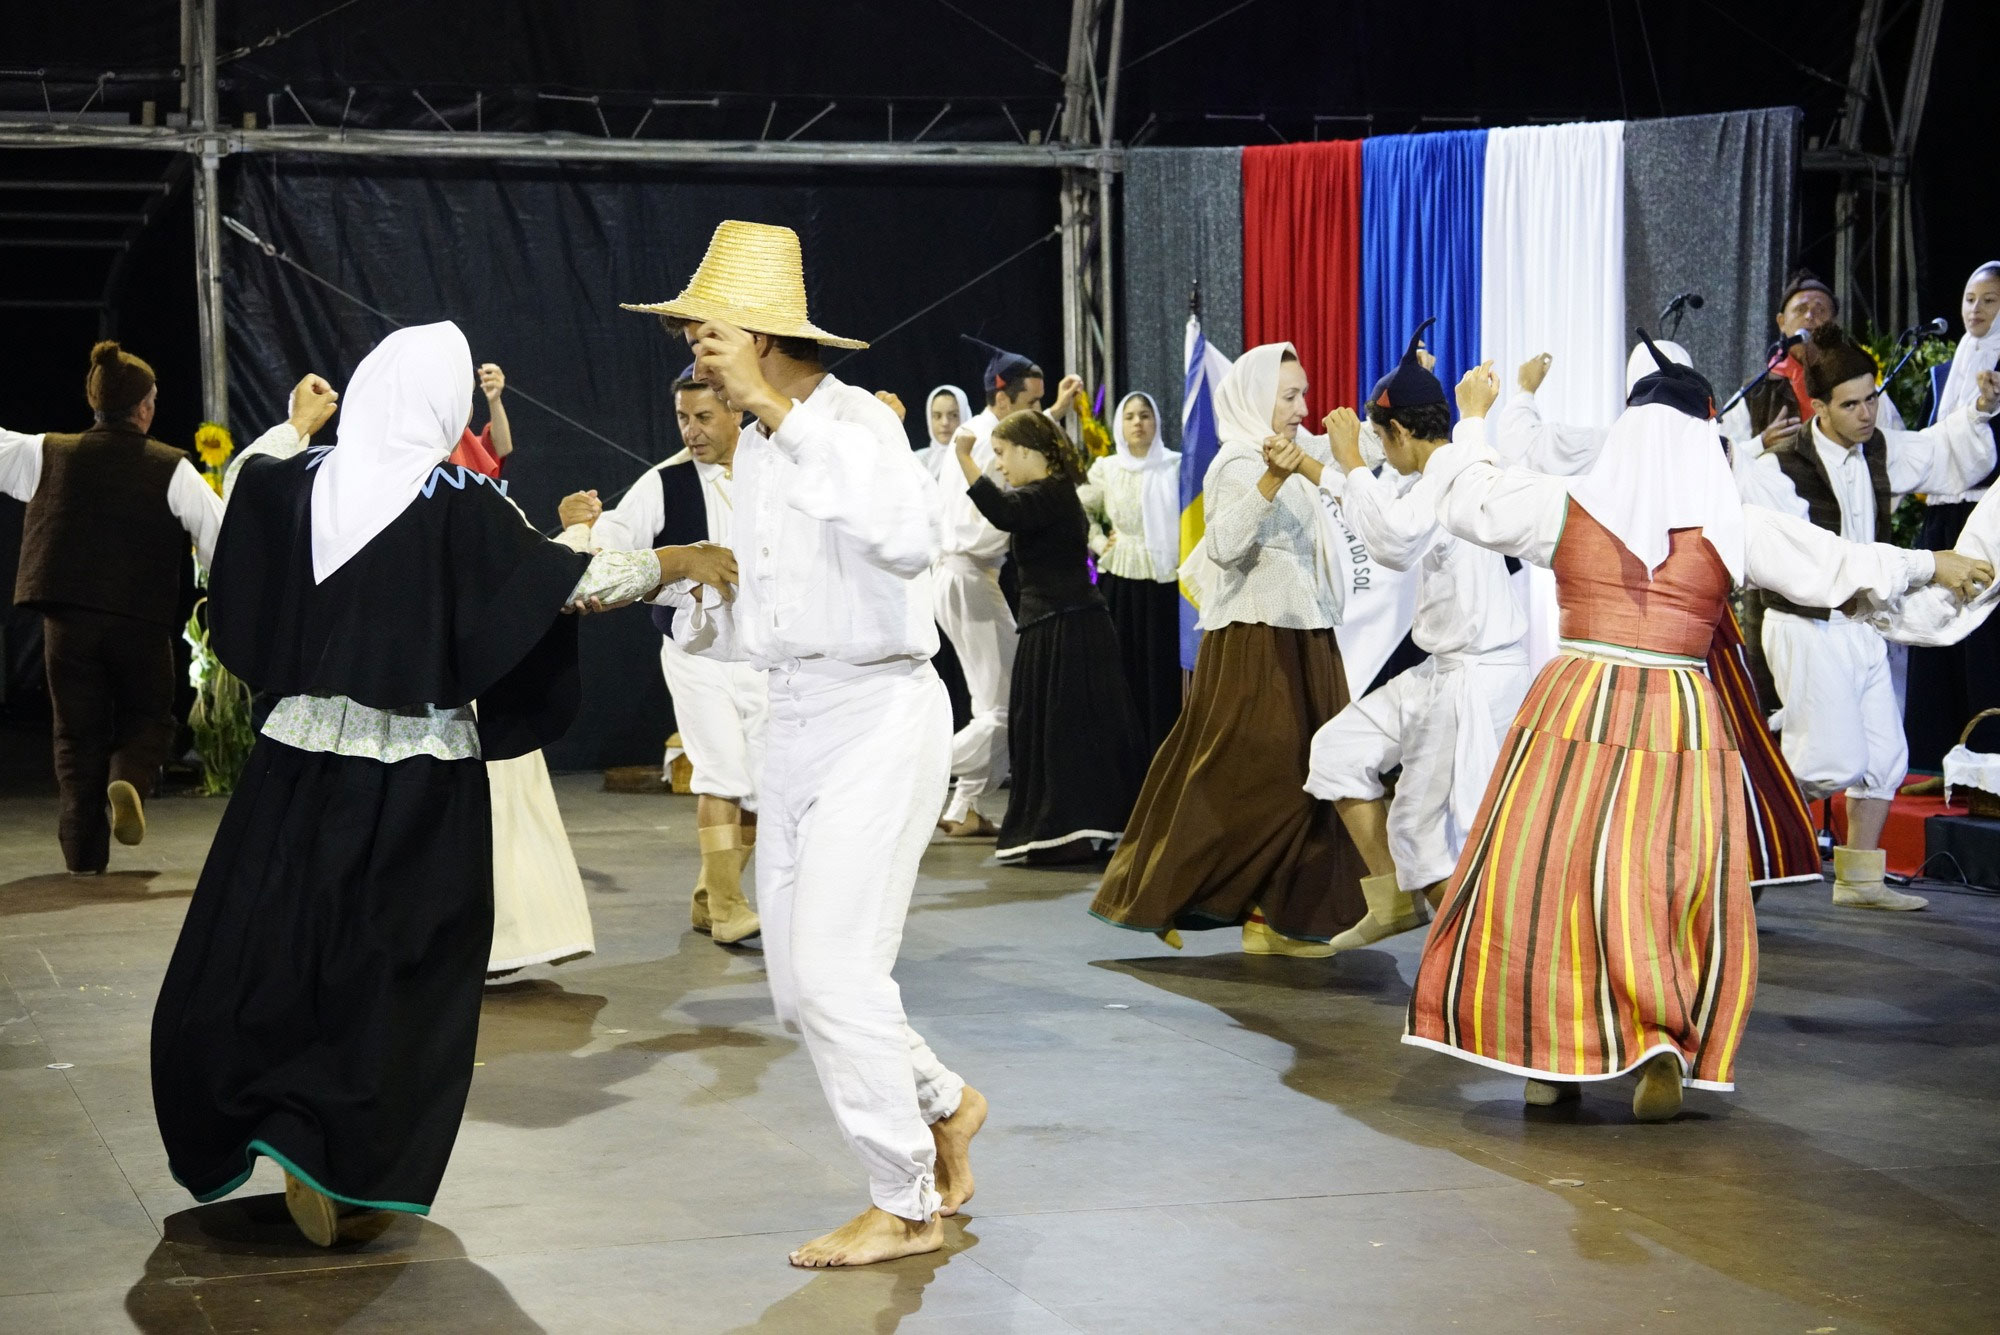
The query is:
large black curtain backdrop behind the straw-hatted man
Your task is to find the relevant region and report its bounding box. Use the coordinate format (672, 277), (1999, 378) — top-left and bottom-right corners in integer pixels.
(224, 156), (1062, 769)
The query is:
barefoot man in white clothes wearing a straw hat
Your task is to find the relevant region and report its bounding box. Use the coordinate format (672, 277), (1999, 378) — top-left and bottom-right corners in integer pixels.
(626, 222), (986, 1267)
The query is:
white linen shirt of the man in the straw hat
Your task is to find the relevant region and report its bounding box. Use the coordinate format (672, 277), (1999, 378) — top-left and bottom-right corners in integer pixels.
(660, 376), (942, 671)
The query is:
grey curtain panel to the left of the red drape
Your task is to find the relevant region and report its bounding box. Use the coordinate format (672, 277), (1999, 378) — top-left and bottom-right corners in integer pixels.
(1116, 148), (1244, 439)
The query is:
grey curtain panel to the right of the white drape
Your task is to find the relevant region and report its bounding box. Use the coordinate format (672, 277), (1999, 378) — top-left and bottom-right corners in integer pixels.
(1624, 106), (1804, 387)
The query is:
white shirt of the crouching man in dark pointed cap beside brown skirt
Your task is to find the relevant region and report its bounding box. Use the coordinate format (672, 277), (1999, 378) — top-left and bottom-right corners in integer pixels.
(1322, 443), (1528, 658)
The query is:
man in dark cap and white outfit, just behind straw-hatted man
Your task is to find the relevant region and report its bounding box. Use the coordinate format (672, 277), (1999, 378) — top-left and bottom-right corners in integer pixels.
(930, 336), (1082, 839)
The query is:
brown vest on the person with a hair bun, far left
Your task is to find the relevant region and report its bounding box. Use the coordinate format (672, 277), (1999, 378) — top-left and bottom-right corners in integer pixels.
(14, 422), (188, 628)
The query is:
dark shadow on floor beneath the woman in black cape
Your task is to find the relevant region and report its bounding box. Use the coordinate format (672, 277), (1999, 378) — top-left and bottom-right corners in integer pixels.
(126, 1195), (542, 1335)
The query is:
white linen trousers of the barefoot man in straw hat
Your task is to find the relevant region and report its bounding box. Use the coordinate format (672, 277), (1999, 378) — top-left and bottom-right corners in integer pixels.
(756, 660), (966, 1219)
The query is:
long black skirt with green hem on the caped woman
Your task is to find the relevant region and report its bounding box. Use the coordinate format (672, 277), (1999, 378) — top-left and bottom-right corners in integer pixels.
(152, 737), (492, 1215)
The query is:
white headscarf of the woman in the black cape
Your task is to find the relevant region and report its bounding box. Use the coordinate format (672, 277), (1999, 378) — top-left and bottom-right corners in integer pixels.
(312, 320), (472, 584)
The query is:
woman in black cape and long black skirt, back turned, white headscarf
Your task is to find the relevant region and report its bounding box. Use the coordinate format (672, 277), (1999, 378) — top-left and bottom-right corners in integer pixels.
(152, 324), (734, 1247)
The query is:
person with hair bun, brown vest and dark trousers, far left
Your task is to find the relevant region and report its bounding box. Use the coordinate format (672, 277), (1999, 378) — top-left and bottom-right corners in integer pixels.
(0, 342), (334, 875)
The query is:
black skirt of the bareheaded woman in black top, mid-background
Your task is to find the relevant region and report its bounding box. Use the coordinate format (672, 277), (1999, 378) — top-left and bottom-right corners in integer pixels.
(994, 608), (1150, 863)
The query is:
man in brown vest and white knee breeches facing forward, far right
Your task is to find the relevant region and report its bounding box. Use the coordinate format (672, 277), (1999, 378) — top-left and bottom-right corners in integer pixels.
(1754, 324), (2000, 909)
